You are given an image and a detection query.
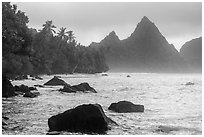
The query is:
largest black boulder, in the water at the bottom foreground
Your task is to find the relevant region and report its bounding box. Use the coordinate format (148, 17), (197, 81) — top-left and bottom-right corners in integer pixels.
(48, 104), (114, 134)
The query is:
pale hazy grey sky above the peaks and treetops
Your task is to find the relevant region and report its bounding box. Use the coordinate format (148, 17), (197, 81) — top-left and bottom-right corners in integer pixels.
(13, 2), (202, 49)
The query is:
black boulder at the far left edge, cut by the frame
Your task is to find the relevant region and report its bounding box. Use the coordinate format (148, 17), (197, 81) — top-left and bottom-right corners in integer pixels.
(2, 76), (16, 98)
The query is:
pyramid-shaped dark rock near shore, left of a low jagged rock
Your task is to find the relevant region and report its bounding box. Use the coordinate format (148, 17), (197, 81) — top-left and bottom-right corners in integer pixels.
(44, 76), (69, 86)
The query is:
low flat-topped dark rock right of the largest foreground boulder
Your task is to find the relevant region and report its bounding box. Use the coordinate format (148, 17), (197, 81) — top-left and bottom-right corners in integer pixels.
(108, 101), (144, 113)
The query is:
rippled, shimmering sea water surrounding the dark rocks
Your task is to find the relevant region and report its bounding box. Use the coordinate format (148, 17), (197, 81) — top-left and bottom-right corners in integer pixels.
(2, 73), (202, 135)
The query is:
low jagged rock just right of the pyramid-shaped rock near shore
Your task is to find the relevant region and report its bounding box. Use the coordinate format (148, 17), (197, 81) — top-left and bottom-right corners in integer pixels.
(59, 83), (97, 93)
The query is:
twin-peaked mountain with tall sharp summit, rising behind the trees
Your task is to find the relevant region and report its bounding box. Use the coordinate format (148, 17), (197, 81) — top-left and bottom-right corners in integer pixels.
(90, 16), (198, 73)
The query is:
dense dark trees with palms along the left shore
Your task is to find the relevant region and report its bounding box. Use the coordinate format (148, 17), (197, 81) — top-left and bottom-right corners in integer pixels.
(2, 2), (108, 75)
